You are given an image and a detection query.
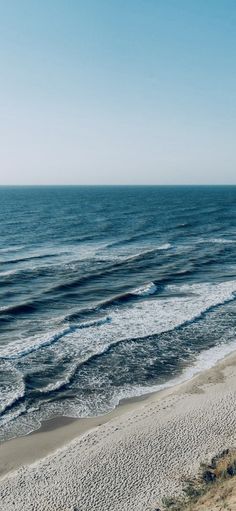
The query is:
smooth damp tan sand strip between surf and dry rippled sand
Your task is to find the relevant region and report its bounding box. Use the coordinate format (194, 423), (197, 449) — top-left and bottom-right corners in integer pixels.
(0, 349), (236, 466)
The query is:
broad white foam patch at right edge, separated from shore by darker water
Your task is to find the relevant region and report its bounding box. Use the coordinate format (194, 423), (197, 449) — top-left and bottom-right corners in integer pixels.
(58, 281), (236, 376)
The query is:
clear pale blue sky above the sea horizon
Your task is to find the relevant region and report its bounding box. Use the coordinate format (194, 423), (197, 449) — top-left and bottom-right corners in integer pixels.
(0, 0), (236, 185)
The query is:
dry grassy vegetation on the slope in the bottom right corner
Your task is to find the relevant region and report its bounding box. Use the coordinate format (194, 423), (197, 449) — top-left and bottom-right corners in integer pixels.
(162, 449), (236, 511)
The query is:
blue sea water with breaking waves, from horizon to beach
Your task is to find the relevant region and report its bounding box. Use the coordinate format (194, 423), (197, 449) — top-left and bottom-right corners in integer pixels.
(0, 186), (236, 439)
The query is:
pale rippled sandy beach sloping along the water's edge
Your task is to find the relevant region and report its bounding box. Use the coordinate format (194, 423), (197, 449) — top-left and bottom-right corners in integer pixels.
(0, 354), (236, 511)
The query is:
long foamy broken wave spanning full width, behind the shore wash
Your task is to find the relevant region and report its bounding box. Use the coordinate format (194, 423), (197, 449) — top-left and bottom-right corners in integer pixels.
(0, 281), (236, 361)
